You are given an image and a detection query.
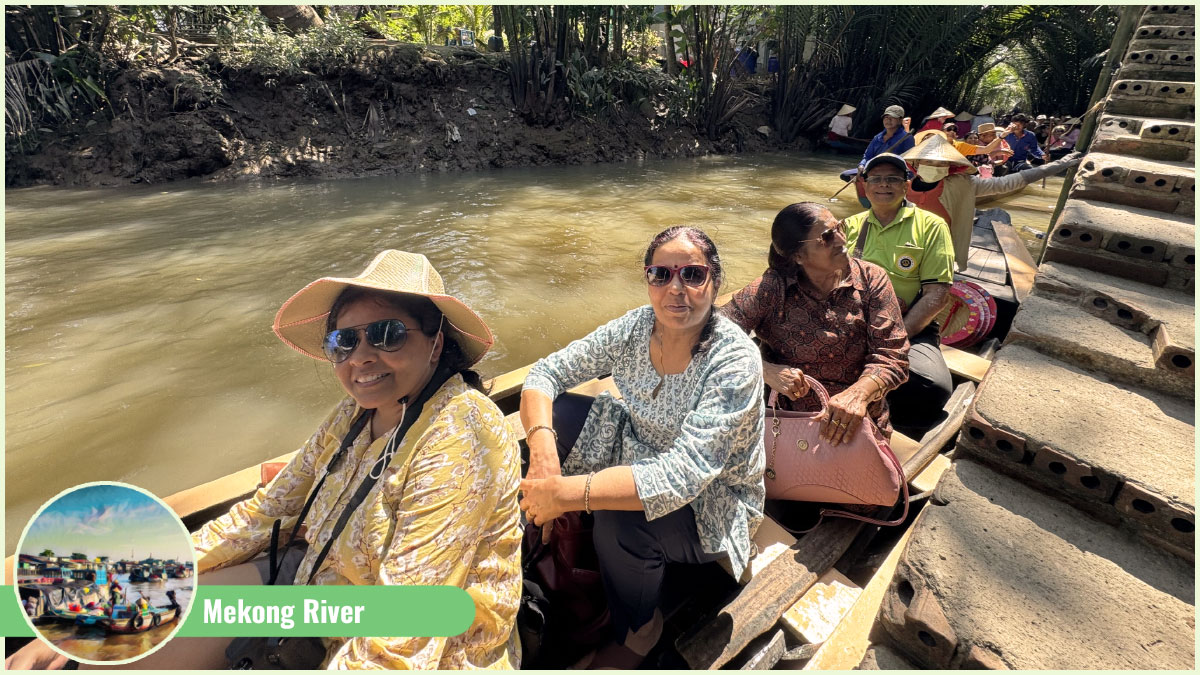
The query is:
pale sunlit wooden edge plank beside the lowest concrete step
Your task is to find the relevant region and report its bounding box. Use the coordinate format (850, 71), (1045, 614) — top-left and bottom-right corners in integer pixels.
(804, 506), (916, 670)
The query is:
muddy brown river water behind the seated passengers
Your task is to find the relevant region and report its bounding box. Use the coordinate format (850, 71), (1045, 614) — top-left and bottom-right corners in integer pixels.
(5, 148), (1062, 551)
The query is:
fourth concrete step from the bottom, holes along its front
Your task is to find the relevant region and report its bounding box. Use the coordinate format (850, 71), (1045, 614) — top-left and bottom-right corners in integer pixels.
(1045, 199), (1195, 292)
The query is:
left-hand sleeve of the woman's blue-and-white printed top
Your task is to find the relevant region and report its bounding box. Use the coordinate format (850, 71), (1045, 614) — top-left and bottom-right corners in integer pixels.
(522, 307), (646, 399)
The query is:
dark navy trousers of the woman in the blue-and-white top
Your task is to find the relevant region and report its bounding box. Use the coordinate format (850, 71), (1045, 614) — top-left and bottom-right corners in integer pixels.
(553, 394), (725, 644)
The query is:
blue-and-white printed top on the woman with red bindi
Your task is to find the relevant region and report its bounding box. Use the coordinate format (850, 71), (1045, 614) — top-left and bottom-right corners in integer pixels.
(524, 305), (766, 578)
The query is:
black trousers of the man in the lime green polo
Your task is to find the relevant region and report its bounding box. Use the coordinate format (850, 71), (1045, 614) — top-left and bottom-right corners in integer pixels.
(888, 324), (954, 441)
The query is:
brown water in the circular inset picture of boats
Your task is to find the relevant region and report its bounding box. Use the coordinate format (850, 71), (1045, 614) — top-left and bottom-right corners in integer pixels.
(36, 574), (192, 662)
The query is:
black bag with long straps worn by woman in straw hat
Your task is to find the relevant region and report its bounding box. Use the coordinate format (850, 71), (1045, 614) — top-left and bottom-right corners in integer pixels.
(226, 365), (454, 670)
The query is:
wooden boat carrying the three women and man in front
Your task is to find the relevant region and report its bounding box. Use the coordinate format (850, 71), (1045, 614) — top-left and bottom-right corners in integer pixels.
(152, 211), (1034, 669)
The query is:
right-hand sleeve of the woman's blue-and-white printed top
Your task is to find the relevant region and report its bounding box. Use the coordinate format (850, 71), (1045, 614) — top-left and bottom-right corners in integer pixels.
(626, 350), (763, 520)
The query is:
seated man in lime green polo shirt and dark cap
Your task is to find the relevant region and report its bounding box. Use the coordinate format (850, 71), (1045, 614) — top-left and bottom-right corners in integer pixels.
(846, 153), (954, 438)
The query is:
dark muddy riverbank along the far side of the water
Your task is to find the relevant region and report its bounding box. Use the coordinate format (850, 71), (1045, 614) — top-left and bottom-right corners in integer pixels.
(5, 43), (808, 187)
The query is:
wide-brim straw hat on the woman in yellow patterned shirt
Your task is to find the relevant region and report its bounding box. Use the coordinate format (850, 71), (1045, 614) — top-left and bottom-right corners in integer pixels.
(271, 250), (496, 365)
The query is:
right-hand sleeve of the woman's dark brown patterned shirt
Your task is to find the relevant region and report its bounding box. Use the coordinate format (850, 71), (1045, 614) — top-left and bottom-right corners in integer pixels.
(863, 263), (908, 392)
